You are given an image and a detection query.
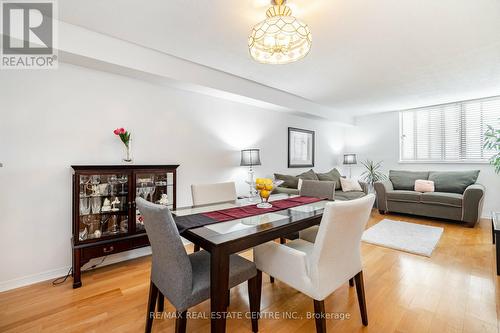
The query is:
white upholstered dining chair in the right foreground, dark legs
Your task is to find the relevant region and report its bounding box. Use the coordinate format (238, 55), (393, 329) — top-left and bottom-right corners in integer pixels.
(254, 194), (375, 333)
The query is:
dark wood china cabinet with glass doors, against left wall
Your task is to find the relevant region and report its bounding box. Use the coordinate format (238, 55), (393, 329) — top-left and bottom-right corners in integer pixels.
(71, 165), (178, 288)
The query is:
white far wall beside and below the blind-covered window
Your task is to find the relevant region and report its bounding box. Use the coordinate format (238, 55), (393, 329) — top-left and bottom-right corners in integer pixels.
(345, 112), (500, 217)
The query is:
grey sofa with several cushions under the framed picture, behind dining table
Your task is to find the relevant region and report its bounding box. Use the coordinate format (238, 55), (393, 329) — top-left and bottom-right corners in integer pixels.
(273, 169), (368, 201)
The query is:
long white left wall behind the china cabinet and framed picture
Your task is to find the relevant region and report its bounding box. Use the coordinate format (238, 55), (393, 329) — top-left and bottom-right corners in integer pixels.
(0, 64), (344, 290)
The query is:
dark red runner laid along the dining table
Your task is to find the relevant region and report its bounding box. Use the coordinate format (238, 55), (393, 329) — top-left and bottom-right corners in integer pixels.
(201, 197), (325, 222)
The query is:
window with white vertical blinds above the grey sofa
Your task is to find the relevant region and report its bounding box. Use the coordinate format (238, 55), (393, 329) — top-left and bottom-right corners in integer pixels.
(399, 97), (500, 163)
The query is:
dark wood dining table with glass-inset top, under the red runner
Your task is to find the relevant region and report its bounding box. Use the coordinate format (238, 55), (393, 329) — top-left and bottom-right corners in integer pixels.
(172, 194), (327, 333)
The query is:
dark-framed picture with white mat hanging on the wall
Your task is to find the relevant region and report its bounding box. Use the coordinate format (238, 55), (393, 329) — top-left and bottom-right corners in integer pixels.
(288, 127), (314, 168)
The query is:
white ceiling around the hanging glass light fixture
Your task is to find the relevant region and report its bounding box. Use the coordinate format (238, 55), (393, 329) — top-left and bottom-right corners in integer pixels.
(59, 0), (500, 115)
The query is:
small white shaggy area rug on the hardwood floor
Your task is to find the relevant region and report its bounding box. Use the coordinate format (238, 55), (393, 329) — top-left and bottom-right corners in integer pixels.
(362, 219), (444, 257)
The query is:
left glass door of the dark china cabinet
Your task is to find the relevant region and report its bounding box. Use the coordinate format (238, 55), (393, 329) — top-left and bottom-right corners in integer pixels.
(77, 173), (130, 242)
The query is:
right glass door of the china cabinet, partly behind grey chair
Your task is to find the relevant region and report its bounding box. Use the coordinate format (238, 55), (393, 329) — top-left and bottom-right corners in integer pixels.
(135, 171), (174, 232)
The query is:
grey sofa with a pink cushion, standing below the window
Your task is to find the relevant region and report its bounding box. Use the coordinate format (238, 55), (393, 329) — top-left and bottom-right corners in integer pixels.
(374, 170), (485, 227)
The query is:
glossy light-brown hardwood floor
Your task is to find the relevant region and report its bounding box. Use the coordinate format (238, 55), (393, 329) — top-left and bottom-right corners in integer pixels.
(0, 211), (500, 333)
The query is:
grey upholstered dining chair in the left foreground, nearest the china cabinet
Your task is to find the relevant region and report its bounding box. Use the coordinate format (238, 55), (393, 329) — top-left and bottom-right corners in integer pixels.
(136, 198), (262, 332)
